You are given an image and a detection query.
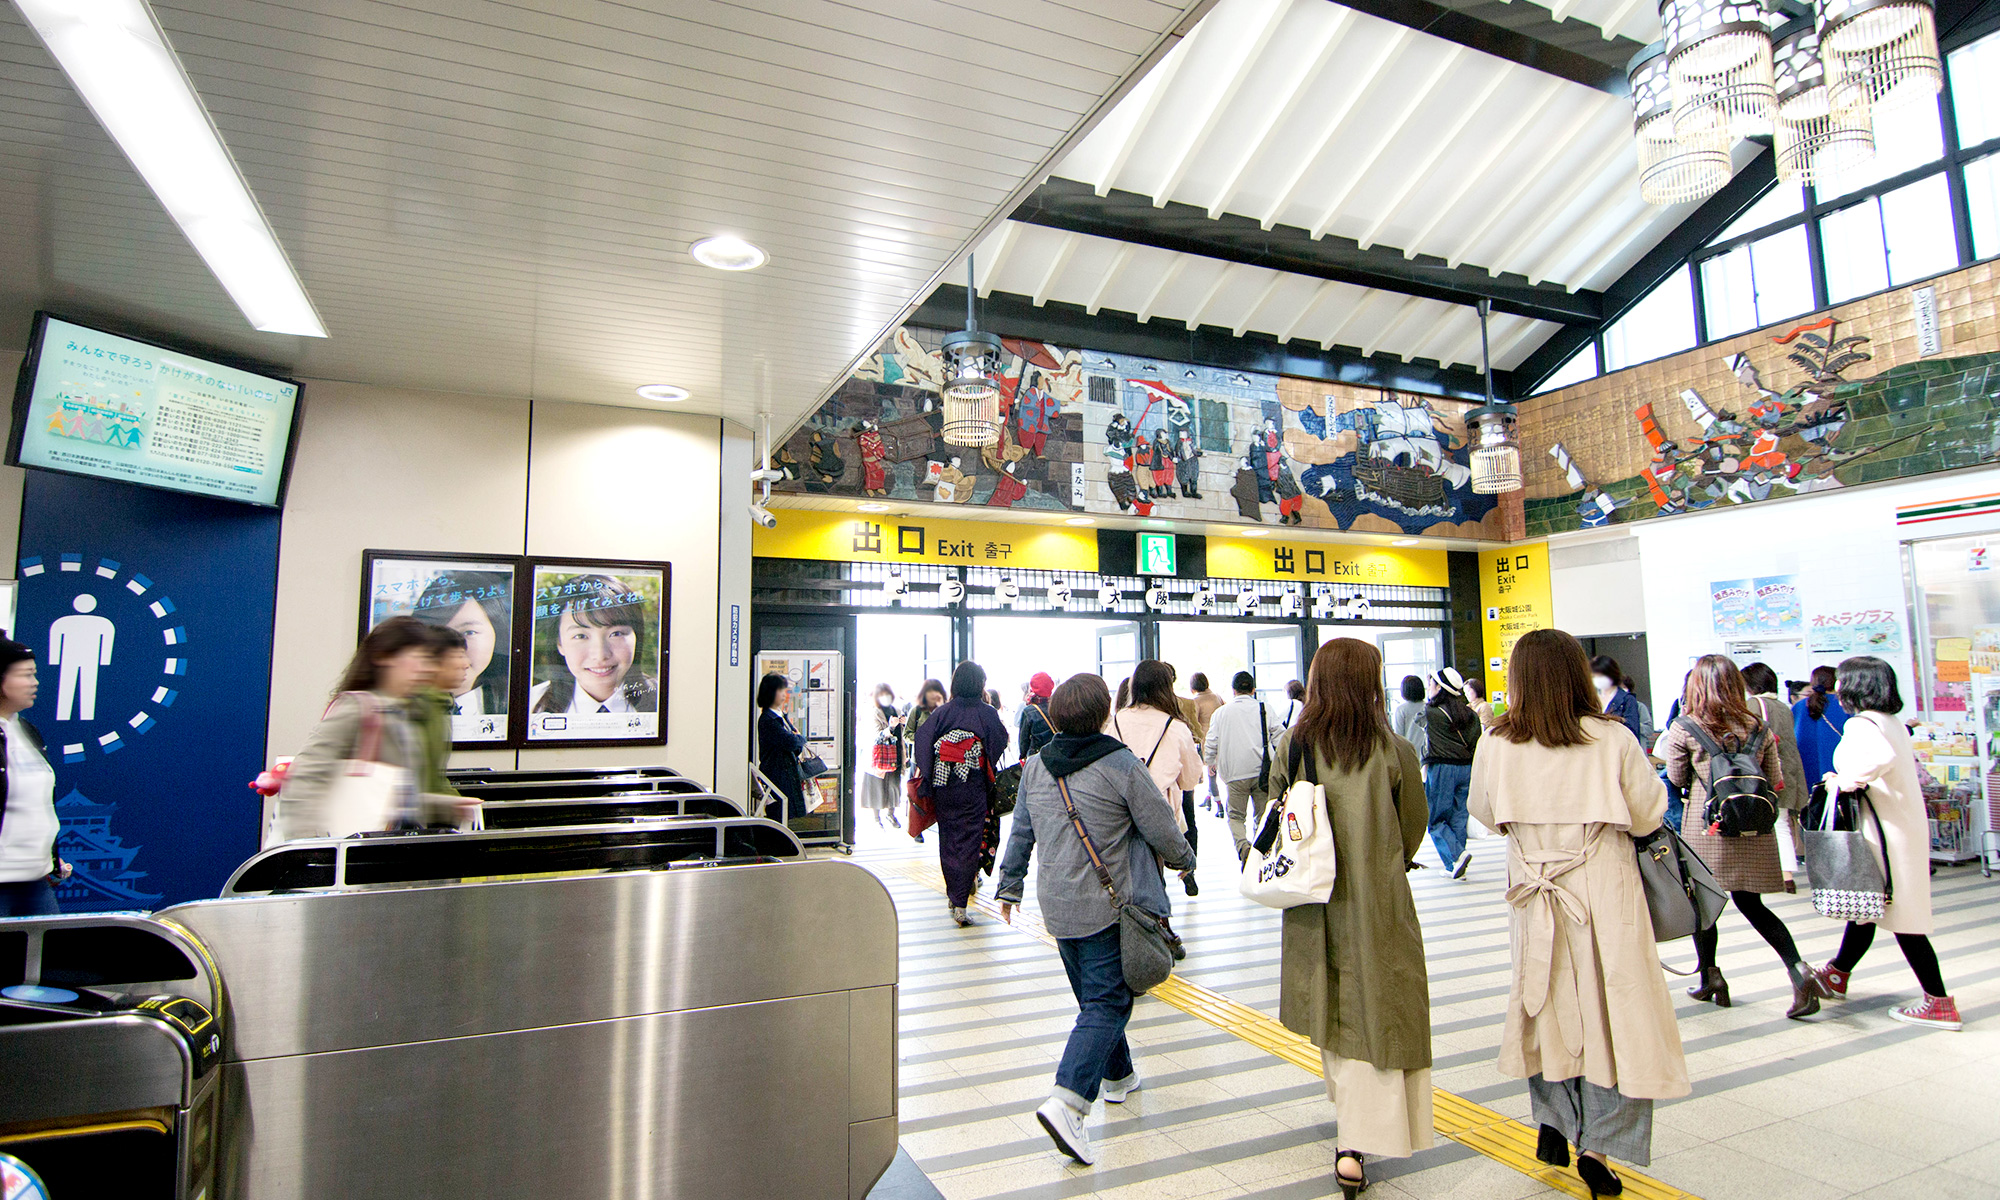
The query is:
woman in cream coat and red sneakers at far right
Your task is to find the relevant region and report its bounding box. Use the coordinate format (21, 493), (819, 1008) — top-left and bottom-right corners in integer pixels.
(1814, 654), (1962, 1030)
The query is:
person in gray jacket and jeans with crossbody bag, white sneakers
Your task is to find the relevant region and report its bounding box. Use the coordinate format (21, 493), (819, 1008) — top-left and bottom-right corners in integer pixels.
(996, 674), (1194, 1164)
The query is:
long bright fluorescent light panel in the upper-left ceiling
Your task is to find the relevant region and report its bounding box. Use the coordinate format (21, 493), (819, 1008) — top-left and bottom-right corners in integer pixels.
(14, 0), (326, 338)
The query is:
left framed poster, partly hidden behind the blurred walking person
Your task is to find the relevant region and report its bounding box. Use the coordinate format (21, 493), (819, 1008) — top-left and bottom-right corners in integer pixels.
(360, 550), (524, 750)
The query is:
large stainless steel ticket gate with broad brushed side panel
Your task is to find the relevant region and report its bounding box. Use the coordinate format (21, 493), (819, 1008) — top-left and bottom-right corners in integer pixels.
(160, 818), (896, 1200)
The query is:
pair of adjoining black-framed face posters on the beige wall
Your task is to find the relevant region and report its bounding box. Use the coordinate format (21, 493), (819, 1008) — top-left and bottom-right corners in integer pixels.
(358, 550), (674, 750)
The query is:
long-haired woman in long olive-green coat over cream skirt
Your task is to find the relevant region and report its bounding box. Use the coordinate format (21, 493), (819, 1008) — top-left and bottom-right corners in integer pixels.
(1270, 638), (1432, 1198)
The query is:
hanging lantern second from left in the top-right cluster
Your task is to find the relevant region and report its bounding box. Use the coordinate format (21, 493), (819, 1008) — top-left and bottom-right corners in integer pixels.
(1660, 0), (1778, 144)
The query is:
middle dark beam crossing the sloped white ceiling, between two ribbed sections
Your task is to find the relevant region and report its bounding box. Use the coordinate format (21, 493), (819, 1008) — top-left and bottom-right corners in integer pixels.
(1012, 178), (1604, 324)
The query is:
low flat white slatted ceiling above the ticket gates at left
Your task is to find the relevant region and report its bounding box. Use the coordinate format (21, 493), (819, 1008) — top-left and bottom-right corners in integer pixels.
(0, 0), (1200, 424)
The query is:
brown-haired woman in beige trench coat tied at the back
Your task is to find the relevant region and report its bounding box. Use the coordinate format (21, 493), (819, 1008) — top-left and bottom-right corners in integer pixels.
(1470, 630), (1690, 1196)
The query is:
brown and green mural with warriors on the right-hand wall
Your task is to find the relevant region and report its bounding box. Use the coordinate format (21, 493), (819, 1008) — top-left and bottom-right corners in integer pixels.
(1520, 264), (2000, 536)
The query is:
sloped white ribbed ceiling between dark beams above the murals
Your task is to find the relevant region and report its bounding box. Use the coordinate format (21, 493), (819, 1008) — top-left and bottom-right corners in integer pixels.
(980, 0), (1754, 368)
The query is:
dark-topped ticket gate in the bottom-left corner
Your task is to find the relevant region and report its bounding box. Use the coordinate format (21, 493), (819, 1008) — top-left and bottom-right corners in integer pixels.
(0, 914), (222, 1200)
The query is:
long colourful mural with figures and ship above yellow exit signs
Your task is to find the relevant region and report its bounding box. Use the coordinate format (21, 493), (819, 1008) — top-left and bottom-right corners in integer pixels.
(774, 326), (1500, 538)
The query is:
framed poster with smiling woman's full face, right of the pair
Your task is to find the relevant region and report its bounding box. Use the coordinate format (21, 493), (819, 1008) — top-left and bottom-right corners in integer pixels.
(528, 562), (668, 744)
